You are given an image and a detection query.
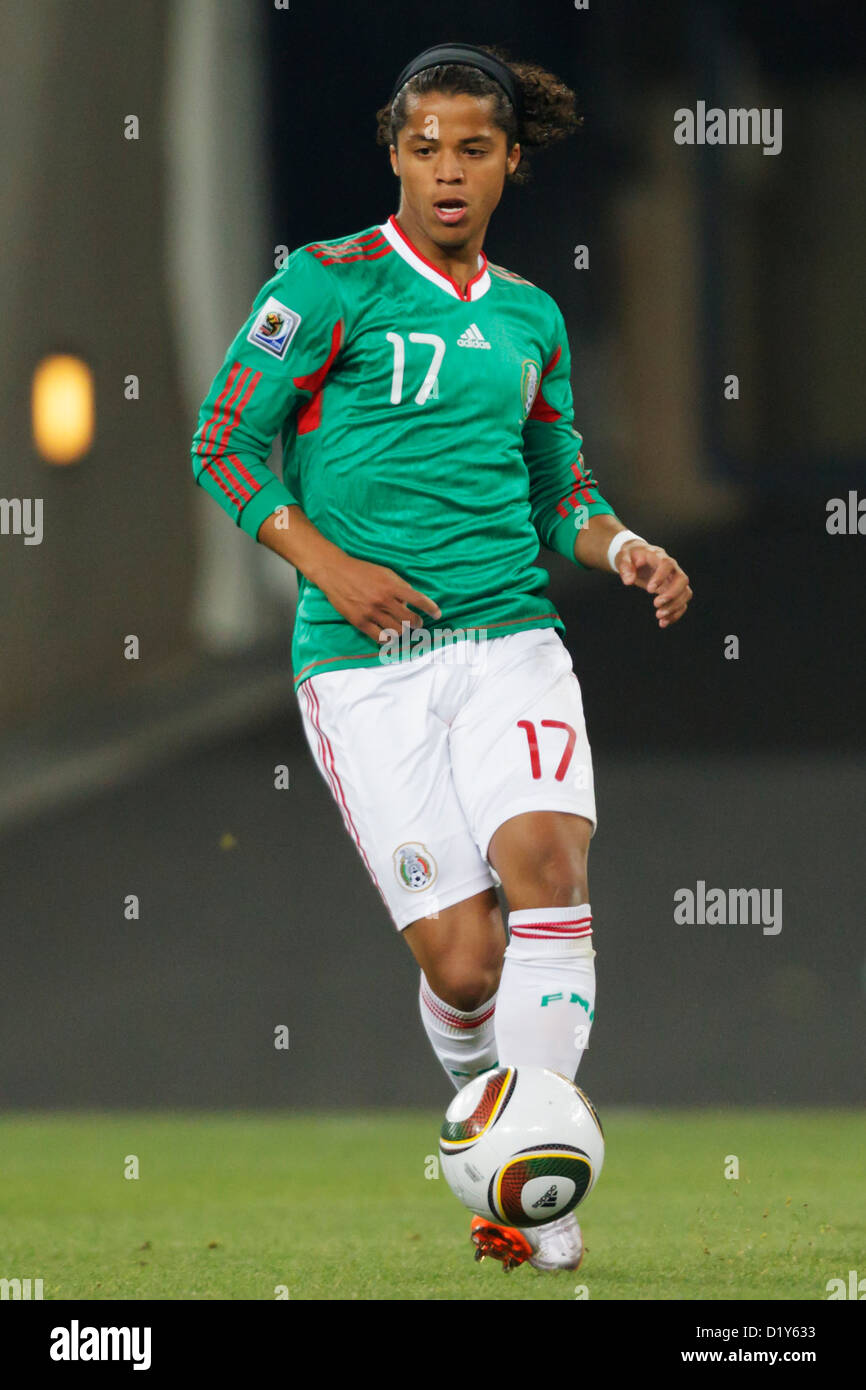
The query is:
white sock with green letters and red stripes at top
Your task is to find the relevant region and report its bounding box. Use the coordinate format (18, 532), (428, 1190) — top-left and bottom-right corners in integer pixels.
(496, 902), (595, 1080)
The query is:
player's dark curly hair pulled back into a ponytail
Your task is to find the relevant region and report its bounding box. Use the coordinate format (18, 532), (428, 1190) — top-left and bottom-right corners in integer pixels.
(375, 43), (584, 185)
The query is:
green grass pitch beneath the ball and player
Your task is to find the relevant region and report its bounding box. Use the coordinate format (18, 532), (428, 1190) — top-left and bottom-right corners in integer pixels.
(0, 1109), (866, 1300)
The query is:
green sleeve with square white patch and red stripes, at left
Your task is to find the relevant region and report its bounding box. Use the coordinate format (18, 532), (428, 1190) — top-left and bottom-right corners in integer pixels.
(192, 249), (343, 538)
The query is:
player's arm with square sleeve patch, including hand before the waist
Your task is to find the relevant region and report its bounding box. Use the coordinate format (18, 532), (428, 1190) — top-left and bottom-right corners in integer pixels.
(192, 249), (441, 641)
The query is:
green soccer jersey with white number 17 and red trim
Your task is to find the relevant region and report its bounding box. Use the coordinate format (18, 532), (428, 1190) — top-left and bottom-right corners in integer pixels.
(192, 217), (613, 688)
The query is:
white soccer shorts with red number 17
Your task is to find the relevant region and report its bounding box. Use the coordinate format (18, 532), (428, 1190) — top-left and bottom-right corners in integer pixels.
(297, 628), (596, 930)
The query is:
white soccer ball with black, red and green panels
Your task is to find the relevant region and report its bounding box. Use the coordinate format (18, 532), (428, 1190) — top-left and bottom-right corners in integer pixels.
(439, 1066), (605, 1226)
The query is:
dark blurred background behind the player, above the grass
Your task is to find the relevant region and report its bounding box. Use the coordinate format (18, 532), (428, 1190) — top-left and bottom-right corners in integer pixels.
(0, 0), (866, 1112)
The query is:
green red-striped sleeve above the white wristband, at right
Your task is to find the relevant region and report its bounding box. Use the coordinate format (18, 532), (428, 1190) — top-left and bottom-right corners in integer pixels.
(523, 309), (613, 569)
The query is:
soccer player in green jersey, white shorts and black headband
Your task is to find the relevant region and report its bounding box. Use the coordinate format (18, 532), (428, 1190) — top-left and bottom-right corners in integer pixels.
(192, 44), (692, 1269)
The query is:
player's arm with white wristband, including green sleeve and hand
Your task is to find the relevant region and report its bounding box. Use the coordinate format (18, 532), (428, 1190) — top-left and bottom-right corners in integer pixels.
(523, 307), (692, 627)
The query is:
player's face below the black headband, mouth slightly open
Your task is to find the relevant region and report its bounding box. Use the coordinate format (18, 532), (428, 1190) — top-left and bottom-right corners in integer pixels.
(391, 92), (520, 250)
